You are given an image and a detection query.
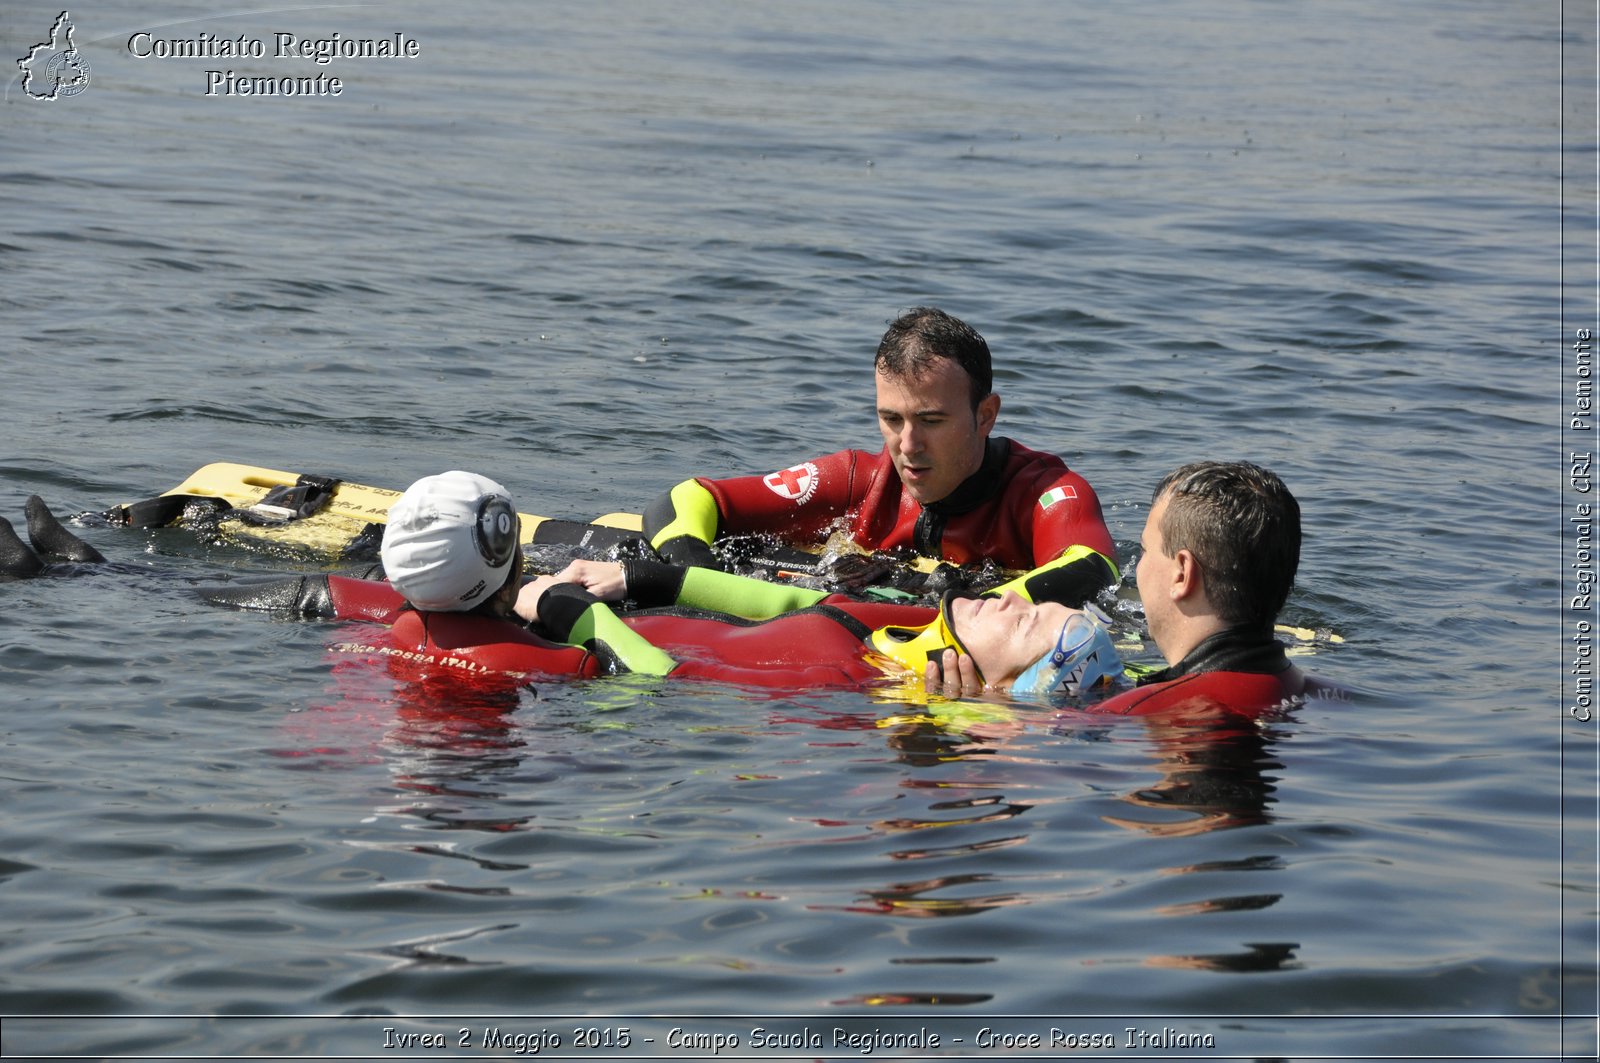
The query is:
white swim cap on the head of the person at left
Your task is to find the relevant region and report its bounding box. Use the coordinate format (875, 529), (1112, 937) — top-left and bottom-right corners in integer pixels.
(379, 471), (518, 612)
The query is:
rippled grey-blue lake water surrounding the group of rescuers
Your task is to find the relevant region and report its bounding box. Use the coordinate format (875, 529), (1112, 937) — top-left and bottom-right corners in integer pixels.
(0, 0), (1600, 1058)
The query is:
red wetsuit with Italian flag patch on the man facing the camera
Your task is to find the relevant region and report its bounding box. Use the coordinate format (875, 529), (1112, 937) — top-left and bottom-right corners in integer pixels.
(643, 439), (1117, 605)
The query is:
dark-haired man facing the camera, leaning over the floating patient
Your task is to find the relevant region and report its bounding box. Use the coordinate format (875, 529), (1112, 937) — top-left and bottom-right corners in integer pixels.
(643, 307), (1117, 605)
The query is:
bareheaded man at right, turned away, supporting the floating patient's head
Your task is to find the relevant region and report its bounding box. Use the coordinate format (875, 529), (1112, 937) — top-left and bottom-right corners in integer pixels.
(944, 461), (1347, 716)
